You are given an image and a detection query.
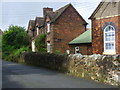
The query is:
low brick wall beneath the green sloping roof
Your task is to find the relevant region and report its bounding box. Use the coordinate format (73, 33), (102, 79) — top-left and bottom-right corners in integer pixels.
(70, 44), (92, 55)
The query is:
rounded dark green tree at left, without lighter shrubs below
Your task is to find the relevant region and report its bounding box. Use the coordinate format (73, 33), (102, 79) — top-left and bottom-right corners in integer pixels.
(3, 25), (28, 48)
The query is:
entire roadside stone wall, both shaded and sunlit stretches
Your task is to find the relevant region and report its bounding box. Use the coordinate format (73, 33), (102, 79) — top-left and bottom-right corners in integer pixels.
(18, 52), (120, 85)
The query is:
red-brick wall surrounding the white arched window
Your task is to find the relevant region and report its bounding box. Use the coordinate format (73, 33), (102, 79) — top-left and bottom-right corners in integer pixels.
(92, 16), (120, 54)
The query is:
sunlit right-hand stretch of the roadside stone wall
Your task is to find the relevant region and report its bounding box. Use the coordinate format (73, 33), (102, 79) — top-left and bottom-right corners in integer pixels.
(68, 54), (120, 85)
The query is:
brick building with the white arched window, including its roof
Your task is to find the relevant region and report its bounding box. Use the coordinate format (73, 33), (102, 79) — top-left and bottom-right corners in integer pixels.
(89, 0), (120, 54)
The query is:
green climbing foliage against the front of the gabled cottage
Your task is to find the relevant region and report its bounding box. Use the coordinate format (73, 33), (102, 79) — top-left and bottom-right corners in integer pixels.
(35, 34), (47, 52)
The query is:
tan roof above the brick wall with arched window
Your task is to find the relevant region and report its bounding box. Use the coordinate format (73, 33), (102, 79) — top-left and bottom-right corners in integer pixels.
(89, 0), (120, 19)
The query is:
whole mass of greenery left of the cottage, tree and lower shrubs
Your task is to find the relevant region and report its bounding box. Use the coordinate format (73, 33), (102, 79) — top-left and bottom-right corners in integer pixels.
(2, 25), (29, 60)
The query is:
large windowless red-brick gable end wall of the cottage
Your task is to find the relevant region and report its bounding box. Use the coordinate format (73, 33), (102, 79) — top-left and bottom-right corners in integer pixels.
(51, 7), (85, 53)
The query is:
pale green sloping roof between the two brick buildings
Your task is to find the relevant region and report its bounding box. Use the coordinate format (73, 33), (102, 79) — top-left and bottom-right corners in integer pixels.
(69, 30), (92, 45)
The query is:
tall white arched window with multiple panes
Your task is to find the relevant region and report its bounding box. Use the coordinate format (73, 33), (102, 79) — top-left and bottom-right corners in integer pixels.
(104, 25), (116, 54)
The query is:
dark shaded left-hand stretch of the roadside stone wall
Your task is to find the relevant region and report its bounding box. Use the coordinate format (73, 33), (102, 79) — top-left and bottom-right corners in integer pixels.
(19, 52), (69, 72)
